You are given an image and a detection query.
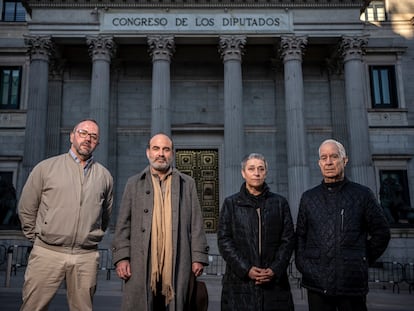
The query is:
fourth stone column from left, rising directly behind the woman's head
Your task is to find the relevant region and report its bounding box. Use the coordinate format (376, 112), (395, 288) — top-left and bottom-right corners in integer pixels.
(219, 36), (246, 196)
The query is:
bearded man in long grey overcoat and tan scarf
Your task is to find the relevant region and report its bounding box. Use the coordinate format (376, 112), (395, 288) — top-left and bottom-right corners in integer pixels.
(112, 134), (208, 311)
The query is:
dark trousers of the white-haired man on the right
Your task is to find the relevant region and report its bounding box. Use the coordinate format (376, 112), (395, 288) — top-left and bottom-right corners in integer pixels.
(308, 290), (368, 311)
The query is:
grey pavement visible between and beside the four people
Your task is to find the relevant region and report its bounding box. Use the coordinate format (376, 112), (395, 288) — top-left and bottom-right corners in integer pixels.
(0, 269), (414, 311)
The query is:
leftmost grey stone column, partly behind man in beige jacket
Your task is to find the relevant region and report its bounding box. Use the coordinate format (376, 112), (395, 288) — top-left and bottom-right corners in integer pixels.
(22, 36), (54, 181)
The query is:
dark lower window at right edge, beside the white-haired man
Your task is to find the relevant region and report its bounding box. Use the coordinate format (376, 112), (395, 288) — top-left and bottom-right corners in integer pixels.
(379, 170), (414, 225)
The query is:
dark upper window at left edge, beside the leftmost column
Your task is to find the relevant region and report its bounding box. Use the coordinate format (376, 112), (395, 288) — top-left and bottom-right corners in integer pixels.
(0, 67), (22, 109)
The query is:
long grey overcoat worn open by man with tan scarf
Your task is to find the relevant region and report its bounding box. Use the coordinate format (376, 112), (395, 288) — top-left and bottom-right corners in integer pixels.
(112, 167), (208, 311)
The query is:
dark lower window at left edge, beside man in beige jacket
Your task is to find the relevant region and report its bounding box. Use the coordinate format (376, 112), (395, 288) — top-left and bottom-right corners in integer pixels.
(0, 171), (20, 229)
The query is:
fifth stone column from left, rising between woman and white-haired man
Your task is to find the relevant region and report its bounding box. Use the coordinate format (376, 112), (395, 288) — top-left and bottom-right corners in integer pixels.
(280, 36), (310, 221)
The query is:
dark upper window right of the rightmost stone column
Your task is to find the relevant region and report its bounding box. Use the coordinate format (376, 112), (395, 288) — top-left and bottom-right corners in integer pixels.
(369, 66), (398, 108)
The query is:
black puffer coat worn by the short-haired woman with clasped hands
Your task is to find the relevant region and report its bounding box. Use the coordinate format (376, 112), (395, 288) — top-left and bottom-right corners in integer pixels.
(217, 184), (295, 311)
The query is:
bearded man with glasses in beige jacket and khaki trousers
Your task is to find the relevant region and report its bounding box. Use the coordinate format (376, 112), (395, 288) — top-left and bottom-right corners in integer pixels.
(18, 119), (113, 311)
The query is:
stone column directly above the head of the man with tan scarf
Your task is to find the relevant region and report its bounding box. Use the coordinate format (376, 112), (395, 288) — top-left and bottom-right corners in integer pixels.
(147, 35), (175, 135)
